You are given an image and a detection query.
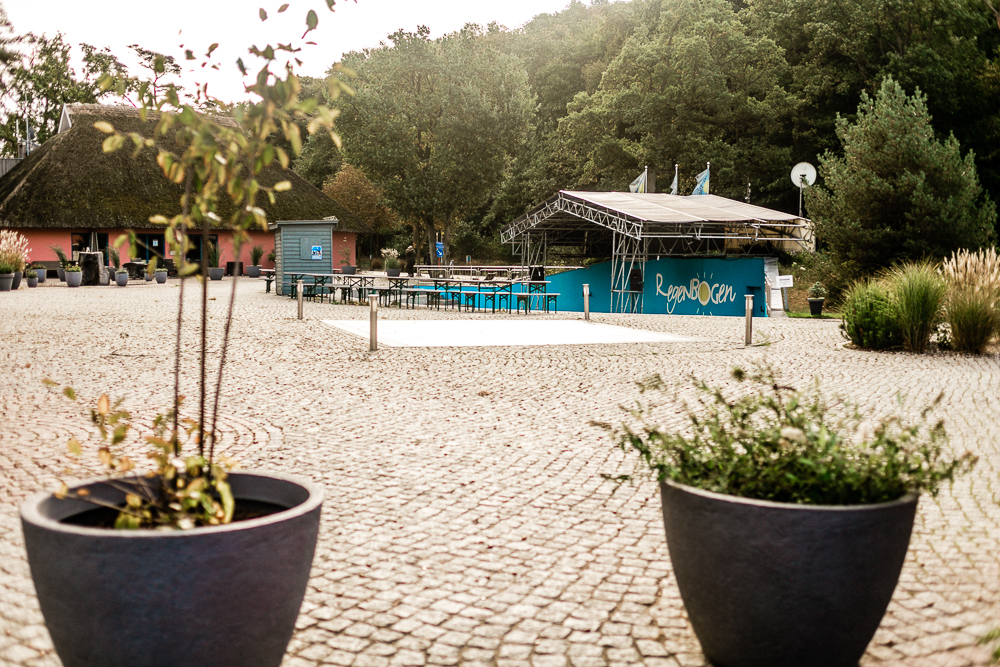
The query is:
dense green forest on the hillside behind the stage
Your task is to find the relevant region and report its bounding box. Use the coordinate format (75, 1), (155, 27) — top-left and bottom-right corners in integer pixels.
(0, 0), (1000, 272)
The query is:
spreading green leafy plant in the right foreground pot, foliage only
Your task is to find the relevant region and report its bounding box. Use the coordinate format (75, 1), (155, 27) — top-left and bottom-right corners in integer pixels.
(596, 368), (976, 505)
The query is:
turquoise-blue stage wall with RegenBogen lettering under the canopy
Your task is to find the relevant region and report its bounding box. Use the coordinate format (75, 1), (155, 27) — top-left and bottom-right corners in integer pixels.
(546, 257), (766, 317)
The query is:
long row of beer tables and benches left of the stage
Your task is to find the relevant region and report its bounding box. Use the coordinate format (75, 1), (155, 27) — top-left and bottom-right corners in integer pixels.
(278, 272), (559, 313)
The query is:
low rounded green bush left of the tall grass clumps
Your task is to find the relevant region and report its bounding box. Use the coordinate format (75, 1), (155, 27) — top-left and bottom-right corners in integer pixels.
(840, 280), (903, 350)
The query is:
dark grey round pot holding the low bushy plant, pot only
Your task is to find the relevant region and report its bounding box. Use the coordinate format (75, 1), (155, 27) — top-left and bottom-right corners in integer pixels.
(660, 482), (917, 667)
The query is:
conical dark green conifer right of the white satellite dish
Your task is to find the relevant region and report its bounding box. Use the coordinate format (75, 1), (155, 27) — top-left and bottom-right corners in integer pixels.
(807, 77), (996, 274)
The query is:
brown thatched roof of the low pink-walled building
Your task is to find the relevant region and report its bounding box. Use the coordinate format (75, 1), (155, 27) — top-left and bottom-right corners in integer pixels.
(0, 104), (370, 232)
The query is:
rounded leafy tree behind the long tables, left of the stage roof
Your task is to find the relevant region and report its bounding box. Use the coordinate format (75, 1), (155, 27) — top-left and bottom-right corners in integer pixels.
(338, 25), (535, 259)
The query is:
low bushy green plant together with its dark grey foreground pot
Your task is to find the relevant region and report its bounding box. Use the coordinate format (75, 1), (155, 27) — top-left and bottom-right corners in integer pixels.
(601, 368), (975, 667)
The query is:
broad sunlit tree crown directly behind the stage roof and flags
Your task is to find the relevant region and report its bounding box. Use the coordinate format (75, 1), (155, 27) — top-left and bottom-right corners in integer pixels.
(560, 0), (794, 205)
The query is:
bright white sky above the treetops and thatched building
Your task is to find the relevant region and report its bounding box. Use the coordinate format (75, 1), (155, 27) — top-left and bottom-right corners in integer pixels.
(0, 0), (580, 100)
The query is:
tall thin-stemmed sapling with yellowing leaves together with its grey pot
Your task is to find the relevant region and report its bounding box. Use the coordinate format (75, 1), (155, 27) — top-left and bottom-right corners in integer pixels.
(21, 12), (346, 667)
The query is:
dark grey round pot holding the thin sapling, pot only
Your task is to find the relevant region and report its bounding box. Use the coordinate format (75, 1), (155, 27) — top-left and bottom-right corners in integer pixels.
(21, 473), (322, 667)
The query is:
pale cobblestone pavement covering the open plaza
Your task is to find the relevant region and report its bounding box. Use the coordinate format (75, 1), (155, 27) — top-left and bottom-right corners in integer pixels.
(0, 280), (1000, 667)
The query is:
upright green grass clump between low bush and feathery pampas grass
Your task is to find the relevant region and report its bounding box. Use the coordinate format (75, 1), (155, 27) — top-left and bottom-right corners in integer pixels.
(887, 261), (948, 354)
